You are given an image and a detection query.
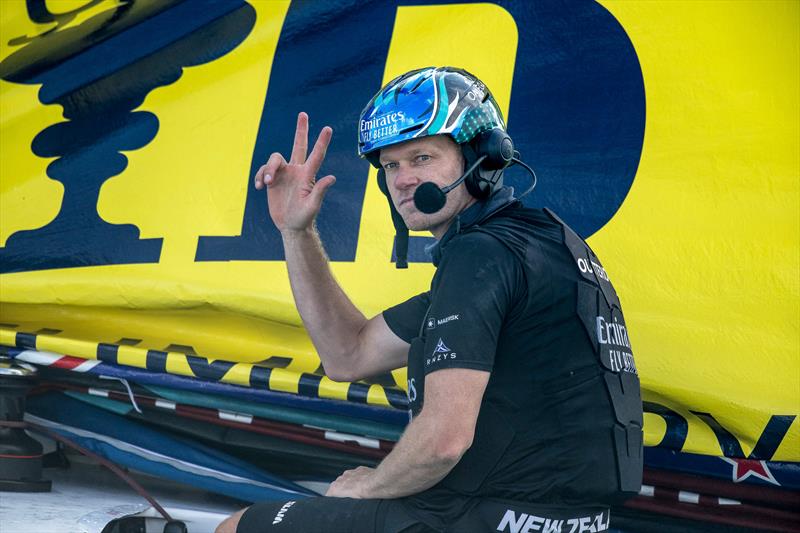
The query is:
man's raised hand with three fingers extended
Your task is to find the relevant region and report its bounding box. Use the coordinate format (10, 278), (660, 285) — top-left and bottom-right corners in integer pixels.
(255, 113), (336, 232)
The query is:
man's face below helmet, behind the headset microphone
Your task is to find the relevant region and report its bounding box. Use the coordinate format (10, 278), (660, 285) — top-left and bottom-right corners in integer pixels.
(380, 135), (475, 239)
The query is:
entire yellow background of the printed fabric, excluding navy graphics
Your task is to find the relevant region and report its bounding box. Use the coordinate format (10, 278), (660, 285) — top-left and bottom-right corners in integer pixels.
(0, 0), (800, 461)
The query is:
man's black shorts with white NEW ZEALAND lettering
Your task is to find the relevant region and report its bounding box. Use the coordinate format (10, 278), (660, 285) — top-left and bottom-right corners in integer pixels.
(236, 497), (610, 533)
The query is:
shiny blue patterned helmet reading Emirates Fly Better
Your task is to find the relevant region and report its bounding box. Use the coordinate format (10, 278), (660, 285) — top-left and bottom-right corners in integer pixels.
(358, 67), (505, 167)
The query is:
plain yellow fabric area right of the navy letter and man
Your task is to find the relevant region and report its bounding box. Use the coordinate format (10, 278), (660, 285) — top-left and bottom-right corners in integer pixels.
(600, 1), (800, 460)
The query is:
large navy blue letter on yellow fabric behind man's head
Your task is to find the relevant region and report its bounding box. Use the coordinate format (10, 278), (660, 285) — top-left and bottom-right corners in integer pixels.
(196, 0), (645, 261)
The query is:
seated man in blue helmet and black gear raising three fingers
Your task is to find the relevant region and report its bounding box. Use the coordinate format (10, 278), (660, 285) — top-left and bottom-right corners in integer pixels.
(218, 67), (642, 533)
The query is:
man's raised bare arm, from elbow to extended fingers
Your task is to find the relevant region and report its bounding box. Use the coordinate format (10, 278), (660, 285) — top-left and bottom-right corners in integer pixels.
(255, 113), (408, 381)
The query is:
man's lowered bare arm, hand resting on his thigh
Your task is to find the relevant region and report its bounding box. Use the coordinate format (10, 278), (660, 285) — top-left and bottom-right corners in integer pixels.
(326, 368), (489, 498)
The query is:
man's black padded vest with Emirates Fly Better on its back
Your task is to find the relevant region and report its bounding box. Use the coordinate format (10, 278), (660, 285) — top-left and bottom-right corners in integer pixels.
(408, 204), (642, 505)
